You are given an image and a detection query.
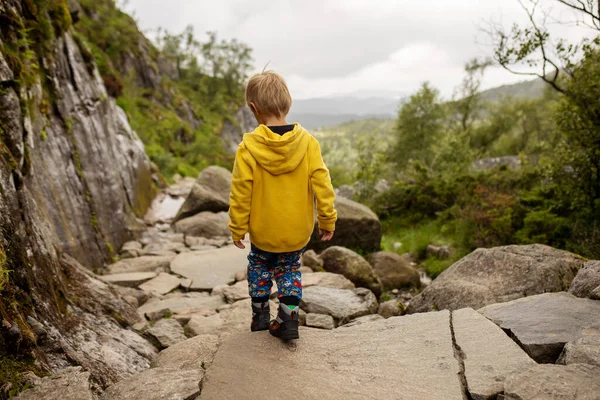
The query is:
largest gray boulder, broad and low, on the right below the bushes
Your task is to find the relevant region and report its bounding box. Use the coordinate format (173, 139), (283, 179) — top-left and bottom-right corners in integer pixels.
(408, 244), (585, 313)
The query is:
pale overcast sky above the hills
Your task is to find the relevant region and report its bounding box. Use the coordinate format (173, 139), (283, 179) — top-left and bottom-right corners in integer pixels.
(125, 0), (586, 99)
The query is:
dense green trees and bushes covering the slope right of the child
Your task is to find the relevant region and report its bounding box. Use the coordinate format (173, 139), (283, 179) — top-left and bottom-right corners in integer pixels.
(321, 13), (600, 276)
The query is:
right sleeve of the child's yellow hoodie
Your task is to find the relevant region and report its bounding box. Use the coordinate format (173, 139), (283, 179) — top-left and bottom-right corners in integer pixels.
(309, 138), (337, 232)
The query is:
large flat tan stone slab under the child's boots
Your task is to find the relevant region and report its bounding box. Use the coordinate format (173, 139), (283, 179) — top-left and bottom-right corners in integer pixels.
(200, 311), (463, 400)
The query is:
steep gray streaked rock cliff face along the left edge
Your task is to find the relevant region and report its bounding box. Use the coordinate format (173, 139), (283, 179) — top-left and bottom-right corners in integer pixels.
(0, 0), (154, 398)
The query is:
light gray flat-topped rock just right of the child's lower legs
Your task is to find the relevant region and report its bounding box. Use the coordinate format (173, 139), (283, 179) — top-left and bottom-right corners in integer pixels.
(300, 286), (379, 325)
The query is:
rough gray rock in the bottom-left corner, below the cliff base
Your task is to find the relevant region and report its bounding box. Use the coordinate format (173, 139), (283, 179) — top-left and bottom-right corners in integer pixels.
(16, 367), (96, 400)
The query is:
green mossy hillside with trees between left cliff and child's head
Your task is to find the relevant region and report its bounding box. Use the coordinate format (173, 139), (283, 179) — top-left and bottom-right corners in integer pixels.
(75, 0), (251, 176)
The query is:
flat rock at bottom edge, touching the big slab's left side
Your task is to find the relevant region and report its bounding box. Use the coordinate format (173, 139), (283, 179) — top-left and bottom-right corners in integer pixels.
(102, 368), (204, 400)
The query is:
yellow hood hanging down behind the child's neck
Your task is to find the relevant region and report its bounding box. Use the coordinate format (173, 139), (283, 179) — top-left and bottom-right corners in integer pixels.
(243, 123), (310, 175)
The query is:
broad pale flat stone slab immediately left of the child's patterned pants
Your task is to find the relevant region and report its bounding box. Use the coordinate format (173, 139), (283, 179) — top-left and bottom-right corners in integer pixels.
(171, 246), (249, 290)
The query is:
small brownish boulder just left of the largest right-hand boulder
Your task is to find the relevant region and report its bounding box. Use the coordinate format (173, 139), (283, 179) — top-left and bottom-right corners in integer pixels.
(369, 251), (421, 290)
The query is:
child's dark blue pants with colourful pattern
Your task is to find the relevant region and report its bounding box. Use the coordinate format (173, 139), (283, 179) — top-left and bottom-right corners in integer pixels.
(248, 245), (306, 299)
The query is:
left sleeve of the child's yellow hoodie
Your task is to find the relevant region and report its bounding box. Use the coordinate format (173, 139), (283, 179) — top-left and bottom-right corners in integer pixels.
(229, 145), (253, 241)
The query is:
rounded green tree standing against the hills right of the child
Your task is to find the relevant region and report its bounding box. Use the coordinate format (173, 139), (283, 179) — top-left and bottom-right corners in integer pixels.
(390, 82), (446, 169)
